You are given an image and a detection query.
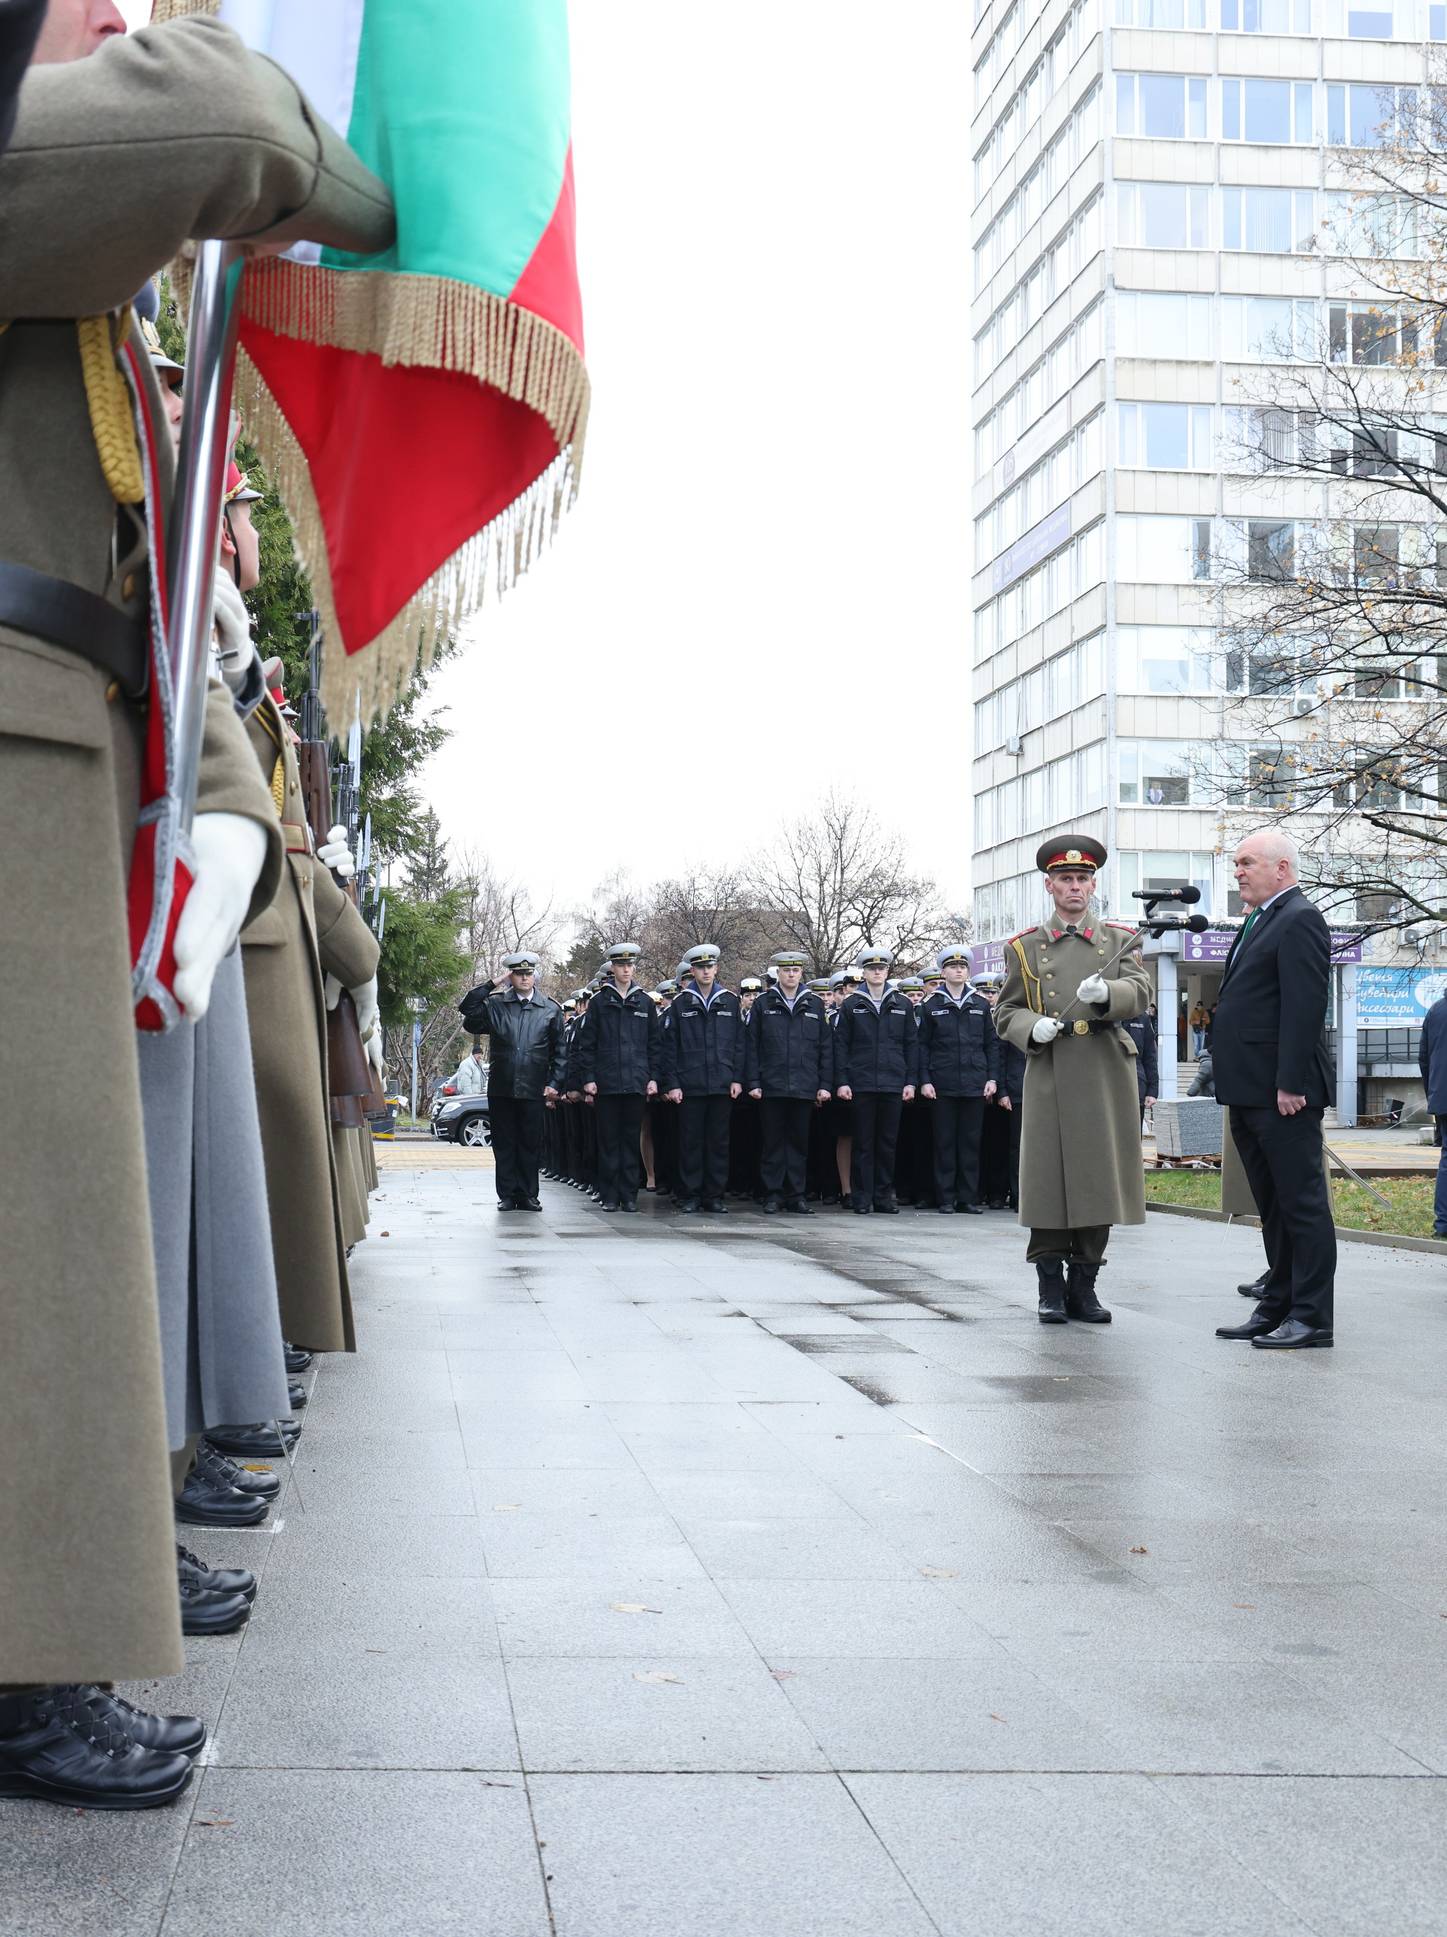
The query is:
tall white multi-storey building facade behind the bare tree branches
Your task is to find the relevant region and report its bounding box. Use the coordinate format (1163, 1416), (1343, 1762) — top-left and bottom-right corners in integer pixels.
(970, 0), (1447, 953)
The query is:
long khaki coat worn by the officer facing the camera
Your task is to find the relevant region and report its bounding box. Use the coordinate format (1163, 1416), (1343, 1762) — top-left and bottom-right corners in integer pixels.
(996, 914), (1151, 1230)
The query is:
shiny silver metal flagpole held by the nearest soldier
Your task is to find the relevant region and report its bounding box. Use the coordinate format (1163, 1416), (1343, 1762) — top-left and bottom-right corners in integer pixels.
(167, 242), (246, 831)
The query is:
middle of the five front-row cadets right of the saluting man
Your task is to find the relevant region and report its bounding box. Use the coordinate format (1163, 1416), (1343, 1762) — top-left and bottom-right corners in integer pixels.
(744, 953), (833, 1216)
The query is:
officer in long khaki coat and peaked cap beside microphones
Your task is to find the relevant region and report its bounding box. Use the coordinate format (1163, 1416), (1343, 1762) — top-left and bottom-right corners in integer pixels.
(996, 835), (1151, 1325)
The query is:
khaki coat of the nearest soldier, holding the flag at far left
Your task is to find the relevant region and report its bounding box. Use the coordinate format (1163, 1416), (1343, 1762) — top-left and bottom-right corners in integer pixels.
(0, 21), (391, 1683)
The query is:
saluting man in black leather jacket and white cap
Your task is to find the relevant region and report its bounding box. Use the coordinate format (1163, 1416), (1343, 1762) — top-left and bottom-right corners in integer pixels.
(457, 951), (566, 1211)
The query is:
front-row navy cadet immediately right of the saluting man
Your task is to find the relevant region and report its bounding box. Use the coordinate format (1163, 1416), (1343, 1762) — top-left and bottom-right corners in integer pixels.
(577, 941), (659, 1211)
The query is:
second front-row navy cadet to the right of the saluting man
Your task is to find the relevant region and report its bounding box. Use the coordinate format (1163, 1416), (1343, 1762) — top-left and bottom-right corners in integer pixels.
(662, 941), (744, 1211)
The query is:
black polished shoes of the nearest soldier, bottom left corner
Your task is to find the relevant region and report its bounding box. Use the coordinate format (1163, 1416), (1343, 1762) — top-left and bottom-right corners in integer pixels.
(0, 1685), (192, 1809)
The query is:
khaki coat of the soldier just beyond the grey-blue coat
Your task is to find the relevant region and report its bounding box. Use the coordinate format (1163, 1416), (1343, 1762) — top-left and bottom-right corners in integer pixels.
(242, 693), (378, 1352)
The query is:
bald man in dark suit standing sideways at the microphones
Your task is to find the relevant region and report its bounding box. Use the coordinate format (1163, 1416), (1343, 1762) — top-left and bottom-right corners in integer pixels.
(1211, 827), (1337, 1352)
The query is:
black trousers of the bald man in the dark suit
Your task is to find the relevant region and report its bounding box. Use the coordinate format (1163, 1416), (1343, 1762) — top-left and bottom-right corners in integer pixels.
(1230, 1102), (1337, 1327)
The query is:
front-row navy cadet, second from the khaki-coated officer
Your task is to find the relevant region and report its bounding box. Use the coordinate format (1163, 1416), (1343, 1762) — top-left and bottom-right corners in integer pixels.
(835, 949), (920, 1216)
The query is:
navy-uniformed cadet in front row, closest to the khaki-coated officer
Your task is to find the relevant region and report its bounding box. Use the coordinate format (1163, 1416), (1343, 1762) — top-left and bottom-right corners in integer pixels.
(920, 943), (1000, 1216)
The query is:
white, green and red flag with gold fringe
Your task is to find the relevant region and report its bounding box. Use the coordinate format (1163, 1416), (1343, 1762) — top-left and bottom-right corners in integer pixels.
(155, 0), (589, 721)
